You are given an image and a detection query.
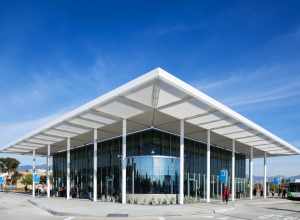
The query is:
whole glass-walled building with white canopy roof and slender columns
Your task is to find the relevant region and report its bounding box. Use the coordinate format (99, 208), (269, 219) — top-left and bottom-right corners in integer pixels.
(2, 68), (300, 204)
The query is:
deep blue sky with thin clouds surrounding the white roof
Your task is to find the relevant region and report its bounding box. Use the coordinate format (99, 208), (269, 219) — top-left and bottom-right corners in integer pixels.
(0, 0), (300, 175)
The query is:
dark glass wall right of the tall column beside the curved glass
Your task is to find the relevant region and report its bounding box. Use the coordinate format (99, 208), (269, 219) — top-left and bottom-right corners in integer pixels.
(184, 139), (246, 202)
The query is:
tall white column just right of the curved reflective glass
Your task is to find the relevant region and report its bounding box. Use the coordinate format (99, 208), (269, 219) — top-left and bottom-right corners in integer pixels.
(179, 120), (184, 205)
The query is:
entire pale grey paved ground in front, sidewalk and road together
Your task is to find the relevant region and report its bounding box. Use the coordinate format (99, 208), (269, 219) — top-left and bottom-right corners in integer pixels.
(0, 192), (300, 220)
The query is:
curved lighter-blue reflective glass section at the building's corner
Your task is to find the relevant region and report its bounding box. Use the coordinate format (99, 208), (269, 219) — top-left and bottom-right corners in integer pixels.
(127, 155), (179, 194)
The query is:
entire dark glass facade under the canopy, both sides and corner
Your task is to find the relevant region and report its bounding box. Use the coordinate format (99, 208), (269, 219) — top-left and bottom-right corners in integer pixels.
(53, 129), (245, 201)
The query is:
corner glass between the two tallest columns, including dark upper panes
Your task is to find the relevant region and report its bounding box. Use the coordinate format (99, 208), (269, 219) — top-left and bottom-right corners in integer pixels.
(127, 129), (179, 194)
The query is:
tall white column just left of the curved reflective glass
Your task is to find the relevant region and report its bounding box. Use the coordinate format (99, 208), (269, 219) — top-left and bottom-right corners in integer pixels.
(122, 119), (127, 204)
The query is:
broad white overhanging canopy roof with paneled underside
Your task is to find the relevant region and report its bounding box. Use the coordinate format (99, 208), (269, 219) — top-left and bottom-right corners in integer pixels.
(2, 68), (300, 157)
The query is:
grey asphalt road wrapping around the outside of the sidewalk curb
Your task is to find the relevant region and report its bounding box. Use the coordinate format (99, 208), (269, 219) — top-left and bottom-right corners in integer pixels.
(0, 193), (300, 220)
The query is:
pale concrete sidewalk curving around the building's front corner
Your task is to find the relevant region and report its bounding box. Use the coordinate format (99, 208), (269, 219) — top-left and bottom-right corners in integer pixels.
(27, 197), (234, 217)
